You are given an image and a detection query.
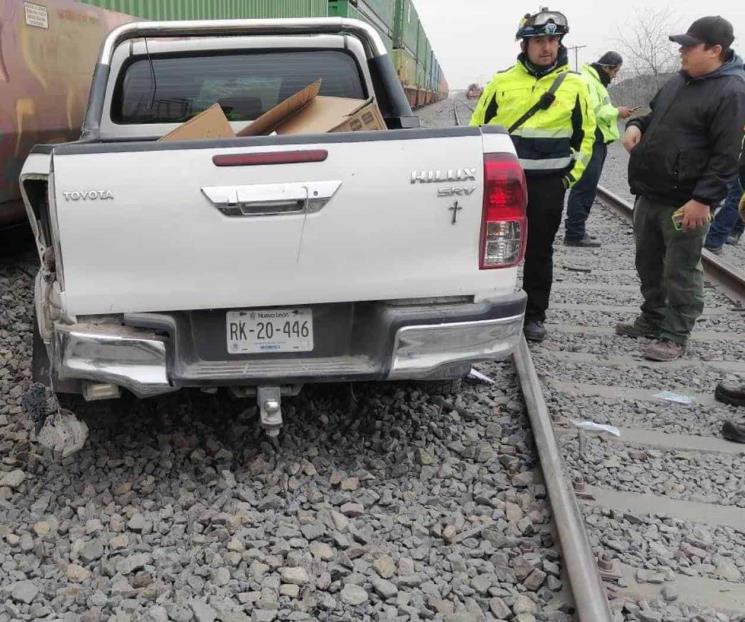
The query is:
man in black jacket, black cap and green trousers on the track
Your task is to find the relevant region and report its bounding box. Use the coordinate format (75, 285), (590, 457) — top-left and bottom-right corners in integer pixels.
(616, 16), (745, 361)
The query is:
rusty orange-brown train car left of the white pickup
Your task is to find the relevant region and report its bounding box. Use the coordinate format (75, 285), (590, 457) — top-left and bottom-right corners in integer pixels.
(0, 0), (132, 240)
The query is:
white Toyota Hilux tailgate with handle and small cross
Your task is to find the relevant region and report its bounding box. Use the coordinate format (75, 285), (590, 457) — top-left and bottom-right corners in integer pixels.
(54, 129), (515, 315)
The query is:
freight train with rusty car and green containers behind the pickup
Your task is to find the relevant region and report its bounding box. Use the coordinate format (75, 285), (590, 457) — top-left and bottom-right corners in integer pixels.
(0, 0), (448, 247)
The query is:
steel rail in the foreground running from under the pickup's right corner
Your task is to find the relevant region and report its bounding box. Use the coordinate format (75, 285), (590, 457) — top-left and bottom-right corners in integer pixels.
(512, 337), (612, 622)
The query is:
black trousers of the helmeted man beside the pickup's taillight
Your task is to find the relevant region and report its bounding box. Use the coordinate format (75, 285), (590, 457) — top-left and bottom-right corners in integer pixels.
(523, 174), (566, 322)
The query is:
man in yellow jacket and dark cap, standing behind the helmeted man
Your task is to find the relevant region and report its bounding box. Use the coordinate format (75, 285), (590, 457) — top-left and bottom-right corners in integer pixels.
(564, 52), (633, 248)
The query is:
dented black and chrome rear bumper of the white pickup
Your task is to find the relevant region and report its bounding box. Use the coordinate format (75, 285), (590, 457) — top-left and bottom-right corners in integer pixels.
(52, 292), (525, 397)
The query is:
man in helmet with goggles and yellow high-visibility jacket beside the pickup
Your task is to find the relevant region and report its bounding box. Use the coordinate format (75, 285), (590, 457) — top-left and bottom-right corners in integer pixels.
(471, 8), (595, 341)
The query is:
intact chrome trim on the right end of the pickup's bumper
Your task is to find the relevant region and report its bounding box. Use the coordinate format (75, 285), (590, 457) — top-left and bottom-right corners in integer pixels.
(388, 314), (523, 380)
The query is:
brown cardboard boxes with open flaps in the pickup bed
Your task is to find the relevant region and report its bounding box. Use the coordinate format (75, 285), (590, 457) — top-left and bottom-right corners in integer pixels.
(160, 80), (386, 141)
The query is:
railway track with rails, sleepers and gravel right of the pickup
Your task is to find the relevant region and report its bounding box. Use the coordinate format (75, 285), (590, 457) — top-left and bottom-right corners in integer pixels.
(453, 98), (745, 621)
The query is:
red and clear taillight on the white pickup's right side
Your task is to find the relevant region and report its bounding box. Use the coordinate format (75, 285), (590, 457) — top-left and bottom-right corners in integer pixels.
(479, 153), (528, 270)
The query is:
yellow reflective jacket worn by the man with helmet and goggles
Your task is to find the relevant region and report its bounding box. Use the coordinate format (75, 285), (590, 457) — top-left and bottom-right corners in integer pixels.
(471, 61), (596, 186)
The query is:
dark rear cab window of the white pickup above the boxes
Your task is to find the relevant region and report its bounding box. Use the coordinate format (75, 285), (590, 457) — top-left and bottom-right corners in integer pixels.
(111, 50), (367, 124)
